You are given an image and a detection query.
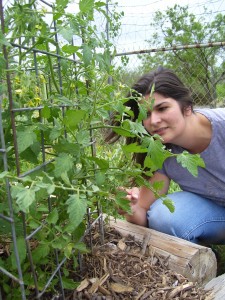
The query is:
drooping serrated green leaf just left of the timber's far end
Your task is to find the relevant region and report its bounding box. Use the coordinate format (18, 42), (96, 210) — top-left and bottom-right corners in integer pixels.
(66, 194), (87, 229)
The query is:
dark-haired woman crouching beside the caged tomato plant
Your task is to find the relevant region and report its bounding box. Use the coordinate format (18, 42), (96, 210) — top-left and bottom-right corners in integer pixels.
(107, 68), (225, 245)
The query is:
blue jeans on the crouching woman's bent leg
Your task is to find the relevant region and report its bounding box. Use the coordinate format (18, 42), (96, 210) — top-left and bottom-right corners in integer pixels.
(147, 192), (225, 245)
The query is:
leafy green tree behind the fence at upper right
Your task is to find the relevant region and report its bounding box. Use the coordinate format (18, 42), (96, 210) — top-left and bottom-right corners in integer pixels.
(139, 5), (225, 106)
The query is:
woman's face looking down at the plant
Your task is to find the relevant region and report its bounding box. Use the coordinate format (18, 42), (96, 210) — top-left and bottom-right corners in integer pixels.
(143, 93), (192, 144)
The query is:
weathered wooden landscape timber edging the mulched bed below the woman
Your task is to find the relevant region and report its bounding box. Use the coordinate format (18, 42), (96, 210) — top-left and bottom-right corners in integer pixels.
(109, 218), (217, 285)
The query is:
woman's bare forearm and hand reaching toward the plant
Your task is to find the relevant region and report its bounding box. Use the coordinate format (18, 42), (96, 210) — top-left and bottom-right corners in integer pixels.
(122, 172), (170, 227)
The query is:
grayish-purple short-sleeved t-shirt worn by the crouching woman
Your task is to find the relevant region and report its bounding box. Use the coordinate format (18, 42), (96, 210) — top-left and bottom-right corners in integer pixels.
(158, 108), (225, 206)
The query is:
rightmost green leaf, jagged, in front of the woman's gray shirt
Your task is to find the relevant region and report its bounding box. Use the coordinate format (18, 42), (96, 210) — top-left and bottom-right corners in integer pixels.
(177, 151), (205, 177)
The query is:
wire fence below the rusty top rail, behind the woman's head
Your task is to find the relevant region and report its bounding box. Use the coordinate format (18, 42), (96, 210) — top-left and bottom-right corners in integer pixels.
(114, 41), (225, 108)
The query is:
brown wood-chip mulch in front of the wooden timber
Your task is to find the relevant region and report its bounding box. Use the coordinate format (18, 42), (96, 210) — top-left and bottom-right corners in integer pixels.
(67, 227), (212, 300)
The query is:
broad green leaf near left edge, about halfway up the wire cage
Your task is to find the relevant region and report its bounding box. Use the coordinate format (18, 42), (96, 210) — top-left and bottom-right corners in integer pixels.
(17, 127), (37, 153)
